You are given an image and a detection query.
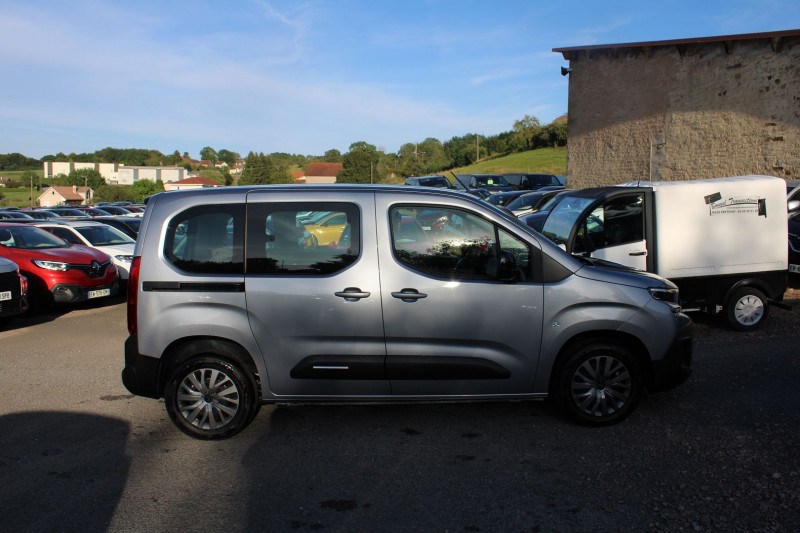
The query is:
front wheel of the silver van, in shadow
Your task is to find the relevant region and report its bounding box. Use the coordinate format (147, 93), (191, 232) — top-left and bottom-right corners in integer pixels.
(555, 339), (644, 426)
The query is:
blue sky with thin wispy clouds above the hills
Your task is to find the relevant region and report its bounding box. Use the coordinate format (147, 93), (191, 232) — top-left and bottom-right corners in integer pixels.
(0, 0), (800, 158)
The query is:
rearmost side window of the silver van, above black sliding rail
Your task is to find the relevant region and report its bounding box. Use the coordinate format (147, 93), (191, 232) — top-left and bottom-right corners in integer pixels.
(164, 204), (244, 274)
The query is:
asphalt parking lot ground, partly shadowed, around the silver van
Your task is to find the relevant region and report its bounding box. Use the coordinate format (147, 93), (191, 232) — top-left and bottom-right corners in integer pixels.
(0, 290), (800, 532)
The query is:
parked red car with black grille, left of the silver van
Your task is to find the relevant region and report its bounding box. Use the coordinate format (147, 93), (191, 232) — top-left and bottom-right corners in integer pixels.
(0, 223), (119, 310)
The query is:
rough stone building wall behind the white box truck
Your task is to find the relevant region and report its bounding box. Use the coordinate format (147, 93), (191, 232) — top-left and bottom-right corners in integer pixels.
(563, 35), (800, 188)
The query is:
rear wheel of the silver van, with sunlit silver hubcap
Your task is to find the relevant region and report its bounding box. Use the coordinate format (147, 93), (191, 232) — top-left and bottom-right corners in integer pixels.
(164, 355), (260, 439)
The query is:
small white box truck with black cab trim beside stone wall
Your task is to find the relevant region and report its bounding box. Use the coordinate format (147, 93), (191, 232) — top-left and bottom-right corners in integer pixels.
(542, 176), (788, 330)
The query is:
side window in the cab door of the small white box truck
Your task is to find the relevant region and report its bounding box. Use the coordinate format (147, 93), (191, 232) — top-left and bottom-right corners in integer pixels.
(573, 194), (644, 253)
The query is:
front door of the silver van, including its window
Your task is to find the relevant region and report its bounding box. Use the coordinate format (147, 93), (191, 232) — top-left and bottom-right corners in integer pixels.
(376, 193), (543, 397)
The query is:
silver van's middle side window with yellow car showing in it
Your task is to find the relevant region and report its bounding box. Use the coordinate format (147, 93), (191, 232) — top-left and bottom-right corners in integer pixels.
(247, 202), (361, 275)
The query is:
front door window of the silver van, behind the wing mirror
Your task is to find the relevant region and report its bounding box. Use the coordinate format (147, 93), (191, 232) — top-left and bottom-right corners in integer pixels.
(390, 206), (530, 280)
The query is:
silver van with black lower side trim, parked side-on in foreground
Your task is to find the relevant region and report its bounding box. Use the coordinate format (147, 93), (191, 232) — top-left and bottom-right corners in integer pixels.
(122, 185), (693, 439)
